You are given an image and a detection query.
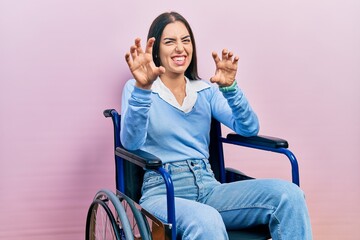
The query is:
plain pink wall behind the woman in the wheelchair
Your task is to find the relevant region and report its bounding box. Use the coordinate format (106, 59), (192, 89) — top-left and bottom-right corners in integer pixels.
(0, 0), (360, 240)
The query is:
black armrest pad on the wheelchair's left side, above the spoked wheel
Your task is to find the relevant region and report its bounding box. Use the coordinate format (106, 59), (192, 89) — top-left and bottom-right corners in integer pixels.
(115, 147), (162, 169)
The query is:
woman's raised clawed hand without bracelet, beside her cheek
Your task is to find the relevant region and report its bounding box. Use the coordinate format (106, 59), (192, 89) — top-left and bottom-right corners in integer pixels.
(125, 38), (165, 89)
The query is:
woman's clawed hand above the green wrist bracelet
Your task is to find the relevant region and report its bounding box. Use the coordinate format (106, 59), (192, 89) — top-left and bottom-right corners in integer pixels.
(210, 49), (239, 87)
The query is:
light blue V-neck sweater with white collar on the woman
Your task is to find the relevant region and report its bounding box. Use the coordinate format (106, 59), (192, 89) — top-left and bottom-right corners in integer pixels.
(120, 78), (259, 163)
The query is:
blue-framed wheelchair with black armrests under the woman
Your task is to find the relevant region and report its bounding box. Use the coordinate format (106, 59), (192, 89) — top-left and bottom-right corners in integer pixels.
(85, 109), (300, 240)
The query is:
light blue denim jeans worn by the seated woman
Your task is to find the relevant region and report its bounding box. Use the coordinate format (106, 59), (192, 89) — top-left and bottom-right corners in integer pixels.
(140, 160), (312, 240)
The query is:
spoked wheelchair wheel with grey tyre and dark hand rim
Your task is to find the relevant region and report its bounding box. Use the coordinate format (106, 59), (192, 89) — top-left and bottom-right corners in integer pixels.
(86, 190), (134, 240)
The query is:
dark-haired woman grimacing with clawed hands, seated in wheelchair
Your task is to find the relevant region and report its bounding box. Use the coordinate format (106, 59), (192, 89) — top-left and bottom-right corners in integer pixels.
(120, 12), (312, 240)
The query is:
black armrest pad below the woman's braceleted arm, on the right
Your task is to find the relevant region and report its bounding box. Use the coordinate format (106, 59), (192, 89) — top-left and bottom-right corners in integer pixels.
(226, 133), (289, 148)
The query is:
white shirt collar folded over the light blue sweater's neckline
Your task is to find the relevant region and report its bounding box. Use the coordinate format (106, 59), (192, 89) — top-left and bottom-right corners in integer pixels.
(151, 77), (210, 113)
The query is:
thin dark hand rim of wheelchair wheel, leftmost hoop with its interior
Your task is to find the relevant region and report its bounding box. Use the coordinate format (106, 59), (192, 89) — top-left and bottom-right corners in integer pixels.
(86, 199), (120, 240)
